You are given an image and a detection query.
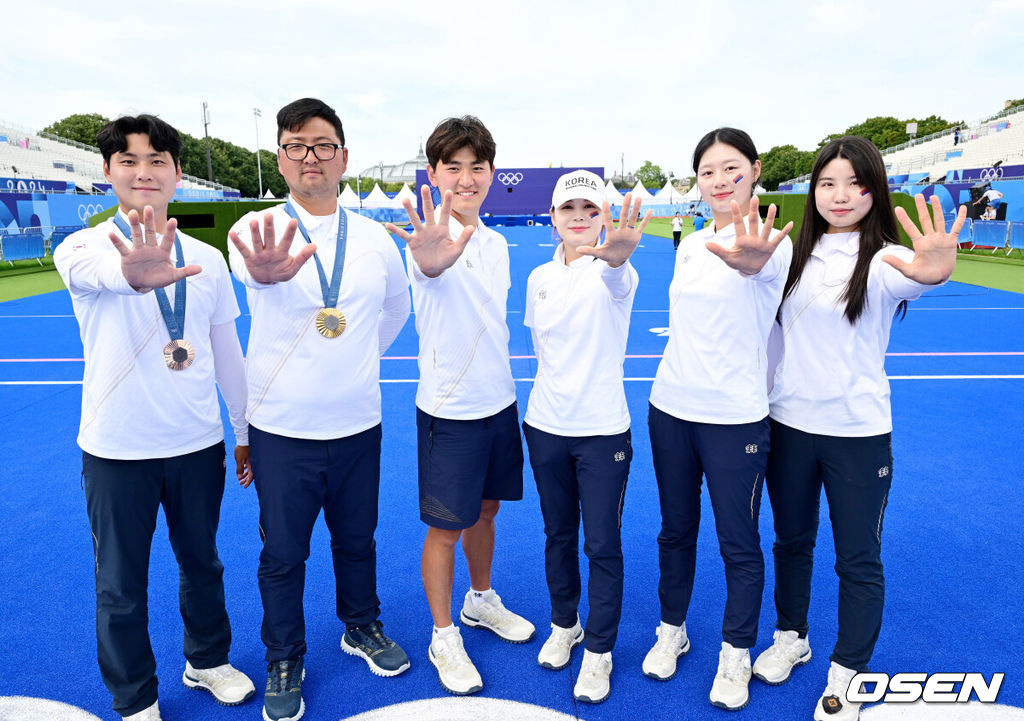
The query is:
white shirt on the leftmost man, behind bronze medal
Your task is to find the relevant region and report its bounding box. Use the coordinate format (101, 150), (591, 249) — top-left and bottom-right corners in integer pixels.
(53, 210), (242, 461)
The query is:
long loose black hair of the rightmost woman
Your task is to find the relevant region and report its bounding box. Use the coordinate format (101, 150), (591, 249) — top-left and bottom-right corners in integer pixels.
(782, 135), (906, 325)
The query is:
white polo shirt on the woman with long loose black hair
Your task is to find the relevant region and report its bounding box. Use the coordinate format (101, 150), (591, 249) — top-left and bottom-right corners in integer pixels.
(769, 232), (934, 436)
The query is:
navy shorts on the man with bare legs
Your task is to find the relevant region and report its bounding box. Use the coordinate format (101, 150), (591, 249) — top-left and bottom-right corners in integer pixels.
(416, 402), (522, 531)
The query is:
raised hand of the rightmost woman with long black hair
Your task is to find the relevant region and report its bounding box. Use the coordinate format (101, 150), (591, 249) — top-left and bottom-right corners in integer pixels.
(882, 195), (967, 286)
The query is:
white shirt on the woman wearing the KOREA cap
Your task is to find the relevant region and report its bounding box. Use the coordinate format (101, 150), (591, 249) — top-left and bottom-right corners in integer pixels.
(524, 244), (638, 436)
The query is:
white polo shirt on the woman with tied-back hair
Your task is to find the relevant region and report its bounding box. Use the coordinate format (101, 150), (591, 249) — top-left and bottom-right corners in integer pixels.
(650, 223), (793, 424)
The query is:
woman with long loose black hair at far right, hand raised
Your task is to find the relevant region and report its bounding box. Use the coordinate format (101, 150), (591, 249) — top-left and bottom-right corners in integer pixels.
(754, 136), (966, 721)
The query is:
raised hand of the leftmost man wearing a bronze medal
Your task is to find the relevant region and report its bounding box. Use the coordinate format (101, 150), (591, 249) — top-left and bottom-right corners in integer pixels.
(110, 206), (203, 293)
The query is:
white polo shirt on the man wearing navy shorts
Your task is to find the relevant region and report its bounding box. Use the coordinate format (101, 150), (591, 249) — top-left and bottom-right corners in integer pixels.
(406, 217), (515, 420)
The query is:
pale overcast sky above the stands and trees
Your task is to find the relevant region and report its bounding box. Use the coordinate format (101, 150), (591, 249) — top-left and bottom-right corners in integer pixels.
(0, 0), (1024, 176)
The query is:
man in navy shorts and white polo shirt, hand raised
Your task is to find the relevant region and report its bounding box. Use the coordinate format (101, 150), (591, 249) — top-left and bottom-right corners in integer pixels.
(388, 116), (535, 694)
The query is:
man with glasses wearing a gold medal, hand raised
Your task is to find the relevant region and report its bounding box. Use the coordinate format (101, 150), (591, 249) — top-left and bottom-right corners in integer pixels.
(229, 98), (410, 721)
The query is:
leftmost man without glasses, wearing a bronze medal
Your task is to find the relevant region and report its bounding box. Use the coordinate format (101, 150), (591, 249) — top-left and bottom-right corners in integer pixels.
(53, 115), (255, 721)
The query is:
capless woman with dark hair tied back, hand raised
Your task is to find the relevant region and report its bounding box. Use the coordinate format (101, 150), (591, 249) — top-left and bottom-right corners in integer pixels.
(643, 128), (793, 711)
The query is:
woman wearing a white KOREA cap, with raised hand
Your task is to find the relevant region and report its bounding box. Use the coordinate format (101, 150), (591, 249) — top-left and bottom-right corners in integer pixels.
(522, 170), (650, 704)
